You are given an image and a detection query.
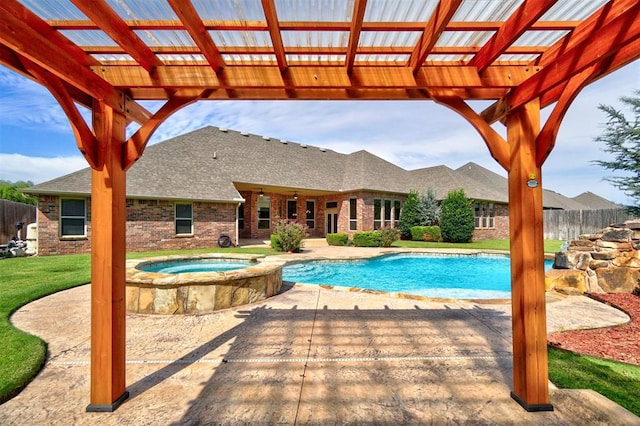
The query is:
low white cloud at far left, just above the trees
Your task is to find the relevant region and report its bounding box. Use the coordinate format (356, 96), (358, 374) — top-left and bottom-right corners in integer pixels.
(0, 153), (89, 184)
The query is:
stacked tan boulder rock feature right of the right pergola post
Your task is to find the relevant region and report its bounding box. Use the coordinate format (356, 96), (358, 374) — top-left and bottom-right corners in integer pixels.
(545, 219), (640, 294)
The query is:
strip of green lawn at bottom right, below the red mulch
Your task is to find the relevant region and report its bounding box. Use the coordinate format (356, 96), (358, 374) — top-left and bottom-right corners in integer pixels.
(549, 348), (640, 416)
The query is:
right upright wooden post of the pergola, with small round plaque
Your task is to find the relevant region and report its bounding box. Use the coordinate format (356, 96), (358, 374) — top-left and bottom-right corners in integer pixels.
(507, 100), (553, 411)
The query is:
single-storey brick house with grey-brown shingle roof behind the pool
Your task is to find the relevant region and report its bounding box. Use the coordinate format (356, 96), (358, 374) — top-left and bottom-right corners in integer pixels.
(25, 126), (616, 255)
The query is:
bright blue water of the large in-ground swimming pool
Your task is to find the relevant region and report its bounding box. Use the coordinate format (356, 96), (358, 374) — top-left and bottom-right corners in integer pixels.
(282, 254), (553, 299)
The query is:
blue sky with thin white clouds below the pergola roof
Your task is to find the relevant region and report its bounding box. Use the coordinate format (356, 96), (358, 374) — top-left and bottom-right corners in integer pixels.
(0, 60), (640, 204)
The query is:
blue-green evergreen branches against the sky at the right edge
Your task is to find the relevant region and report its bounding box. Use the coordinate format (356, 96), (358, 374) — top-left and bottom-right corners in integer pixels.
(593, 90), (640, 208)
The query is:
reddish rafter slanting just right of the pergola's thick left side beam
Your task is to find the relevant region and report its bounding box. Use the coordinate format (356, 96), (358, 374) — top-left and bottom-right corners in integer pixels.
(71, 0), (163, 72)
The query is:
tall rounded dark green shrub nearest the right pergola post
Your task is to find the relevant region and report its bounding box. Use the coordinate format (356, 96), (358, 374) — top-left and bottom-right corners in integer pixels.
(440, 189), (475, 243)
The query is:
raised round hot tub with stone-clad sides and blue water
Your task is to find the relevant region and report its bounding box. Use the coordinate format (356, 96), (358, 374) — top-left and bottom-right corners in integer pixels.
(126, 253), (285, 315)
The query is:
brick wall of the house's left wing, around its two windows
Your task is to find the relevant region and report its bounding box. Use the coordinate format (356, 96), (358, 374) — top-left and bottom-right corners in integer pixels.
(38, 196), (237, 256)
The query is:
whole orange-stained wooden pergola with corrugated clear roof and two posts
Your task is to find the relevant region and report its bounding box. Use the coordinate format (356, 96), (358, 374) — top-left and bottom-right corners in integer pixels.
(0, 0), (640, 411)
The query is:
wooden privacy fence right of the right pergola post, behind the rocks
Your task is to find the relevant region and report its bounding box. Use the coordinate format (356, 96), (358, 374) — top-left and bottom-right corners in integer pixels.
(544, 209), (637, 241)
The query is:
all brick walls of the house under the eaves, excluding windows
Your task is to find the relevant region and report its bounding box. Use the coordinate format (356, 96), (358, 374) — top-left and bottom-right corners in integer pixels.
(38, 192), (509, 255)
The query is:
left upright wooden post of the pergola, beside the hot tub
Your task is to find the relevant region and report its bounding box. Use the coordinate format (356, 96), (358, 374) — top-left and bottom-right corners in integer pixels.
(87, 103), (129, 412)
